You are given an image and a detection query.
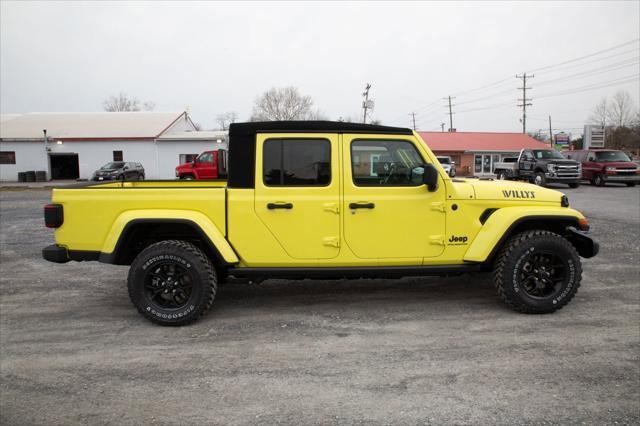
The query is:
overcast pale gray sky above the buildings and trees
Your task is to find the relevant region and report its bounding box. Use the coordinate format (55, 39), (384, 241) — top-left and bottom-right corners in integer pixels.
(0, 1), (640, 133)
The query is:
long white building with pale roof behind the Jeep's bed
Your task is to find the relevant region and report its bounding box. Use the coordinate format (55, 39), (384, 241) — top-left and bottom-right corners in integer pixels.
(0, 112), (227, 181)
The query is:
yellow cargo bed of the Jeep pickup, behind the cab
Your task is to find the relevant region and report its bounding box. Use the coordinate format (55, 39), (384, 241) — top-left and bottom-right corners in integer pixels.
(52, 180), (226, 254)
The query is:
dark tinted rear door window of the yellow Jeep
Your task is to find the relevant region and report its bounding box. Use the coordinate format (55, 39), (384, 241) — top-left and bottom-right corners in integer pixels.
(262, 139), (331, 186)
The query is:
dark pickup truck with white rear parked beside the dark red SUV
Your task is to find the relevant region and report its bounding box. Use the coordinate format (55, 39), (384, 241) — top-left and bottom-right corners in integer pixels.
(494, 149), (581, 188)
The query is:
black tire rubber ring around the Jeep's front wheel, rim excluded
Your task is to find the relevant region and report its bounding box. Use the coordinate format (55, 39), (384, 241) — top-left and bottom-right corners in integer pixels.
(493, 230), (582, 314)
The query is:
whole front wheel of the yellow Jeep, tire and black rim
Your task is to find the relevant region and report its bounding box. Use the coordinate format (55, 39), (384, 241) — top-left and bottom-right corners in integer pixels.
(493, 230), (582, 314)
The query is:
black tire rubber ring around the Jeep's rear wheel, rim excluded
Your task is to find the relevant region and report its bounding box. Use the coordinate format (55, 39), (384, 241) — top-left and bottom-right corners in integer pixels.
(127, 240), (218, 326)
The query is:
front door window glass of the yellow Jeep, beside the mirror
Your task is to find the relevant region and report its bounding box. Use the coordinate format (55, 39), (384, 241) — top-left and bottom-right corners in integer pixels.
(351, 140), (425, 186)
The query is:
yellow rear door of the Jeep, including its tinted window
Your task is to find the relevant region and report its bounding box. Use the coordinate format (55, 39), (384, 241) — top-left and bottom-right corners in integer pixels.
(254, 134), (341, 259)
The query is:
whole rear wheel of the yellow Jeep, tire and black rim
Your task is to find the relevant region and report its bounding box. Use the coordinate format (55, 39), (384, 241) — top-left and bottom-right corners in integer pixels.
(127, 240), (217, 326)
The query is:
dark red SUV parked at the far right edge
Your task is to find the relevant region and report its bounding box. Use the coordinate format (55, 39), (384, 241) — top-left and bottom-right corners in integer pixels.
(564, 149), (640, 186)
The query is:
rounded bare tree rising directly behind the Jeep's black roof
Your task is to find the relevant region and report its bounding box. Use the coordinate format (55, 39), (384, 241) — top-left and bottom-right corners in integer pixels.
(251, 87), (319, 121)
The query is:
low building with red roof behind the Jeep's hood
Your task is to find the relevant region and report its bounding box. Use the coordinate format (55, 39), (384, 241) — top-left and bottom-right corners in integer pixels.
(418, 132), (549, 176)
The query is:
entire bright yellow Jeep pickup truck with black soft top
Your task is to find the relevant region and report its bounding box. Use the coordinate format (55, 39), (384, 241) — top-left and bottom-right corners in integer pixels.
(43, 121), (598, 325)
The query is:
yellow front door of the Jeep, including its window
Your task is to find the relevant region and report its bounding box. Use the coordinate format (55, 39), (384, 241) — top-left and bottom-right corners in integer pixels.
(342, 135), (445, 261)
